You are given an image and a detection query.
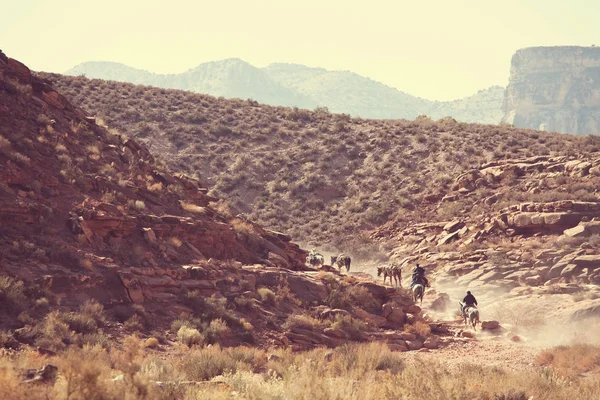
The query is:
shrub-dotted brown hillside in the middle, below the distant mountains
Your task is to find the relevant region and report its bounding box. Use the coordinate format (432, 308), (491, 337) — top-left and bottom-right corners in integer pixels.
(44, 75), (597, 254)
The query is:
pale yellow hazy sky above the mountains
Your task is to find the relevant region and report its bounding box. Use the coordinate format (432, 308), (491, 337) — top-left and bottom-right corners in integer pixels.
(0, 0), (600, 100)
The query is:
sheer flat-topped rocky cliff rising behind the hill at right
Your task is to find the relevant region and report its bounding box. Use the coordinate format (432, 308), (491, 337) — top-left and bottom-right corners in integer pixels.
(503, 46), (600, 134)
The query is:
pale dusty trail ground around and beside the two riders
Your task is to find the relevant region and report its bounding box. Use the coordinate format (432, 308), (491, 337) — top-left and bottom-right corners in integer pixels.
(353, 263), (600, 371)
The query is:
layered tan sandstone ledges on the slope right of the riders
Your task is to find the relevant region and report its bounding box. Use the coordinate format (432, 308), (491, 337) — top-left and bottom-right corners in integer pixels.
(373, 152), (600, 328)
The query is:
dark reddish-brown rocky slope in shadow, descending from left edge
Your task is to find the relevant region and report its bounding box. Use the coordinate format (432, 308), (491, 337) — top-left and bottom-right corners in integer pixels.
(0, 53), (462, 360)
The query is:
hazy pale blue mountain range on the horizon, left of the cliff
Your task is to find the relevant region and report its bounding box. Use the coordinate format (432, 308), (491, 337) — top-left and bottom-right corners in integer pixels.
(66, 58), (504, 123)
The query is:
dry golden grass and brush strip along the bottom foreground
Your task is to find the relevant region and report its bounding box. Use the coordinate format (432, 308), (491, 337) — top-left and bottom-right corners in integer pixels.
(0, 336), (600, 400)
